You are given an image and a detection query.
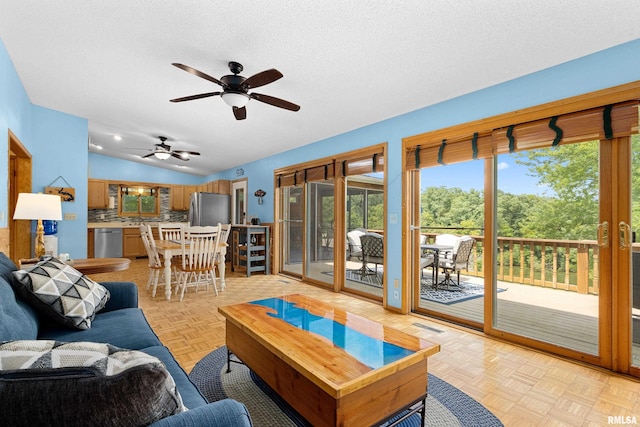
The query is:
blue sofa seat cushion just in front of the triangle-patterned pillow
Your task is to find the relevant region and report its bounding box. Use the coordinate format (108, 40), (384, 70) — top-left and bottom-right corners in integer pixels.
(38, 308), (162, 350)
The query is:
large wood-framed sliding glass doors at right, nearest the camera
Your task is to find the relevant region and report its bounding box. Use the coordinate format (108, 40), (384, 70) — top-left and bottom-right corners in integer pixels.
(405, 96), (640, 376)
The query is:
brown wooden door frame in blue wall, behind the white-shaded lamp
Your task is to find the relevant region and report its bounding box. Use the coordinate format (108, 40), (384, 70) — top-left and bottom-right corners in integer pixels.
(7, 130), (32, 263)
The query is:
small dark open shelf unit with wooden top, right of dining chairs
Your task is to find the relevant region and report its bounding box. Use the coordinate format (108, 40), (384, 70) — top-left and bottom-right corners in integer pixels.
(231, 225), (270, 277)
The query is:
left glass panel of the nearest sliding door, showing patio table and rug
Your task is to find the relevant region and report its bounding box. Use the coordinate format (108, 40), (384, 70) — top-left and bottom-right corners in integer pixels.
(412, 160), (485, 329)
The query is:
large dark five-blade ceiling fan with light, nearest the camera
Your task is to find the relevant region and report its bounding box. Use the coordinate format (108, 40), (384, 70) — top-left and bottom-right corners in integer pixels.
(170, 61), (300, 120)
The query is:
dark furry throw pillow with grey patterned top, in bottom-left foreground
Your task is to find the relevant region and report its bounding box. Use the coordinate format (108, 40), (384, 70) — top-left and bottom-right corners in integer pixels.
(0, 340), (186, 426)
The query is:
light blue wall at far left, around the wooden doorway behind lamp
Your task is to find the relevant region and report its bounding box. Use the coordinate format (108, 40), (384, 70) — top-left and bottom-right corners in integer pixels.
(0, 44), (88, 258)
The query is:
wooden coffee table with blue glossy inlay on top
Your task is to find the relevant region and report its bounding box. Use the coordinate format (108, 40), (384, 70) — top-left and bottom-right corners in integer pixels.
(218, 294), (440, 426)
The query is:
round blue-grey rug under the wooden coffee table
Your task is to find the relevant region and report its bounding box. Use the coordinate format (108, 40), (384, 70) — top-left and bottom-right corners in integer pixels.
(189, 346), (503, 427)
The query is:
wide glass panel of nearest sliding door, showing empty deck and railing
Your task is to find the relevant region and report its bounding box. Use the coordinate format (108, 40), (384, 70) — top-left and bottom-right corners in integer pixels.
(493, 141), (611, 357)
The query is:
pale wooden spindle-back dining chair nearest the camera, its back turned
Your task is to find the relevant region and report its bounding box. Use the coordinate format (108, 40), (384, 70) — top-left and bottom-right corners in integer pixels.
(176, 224), (222, 301)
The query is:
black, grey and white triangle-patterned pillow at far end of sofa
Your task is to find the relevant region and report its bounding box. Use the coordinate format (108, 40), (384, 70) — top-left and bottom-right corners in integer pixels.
(13, 256), (110, 329)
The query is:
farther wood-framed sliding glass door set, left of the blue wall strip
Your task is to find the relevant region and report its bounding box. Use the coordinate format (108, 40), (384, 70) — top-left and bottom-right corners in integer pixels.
(274, 144), (386, 300)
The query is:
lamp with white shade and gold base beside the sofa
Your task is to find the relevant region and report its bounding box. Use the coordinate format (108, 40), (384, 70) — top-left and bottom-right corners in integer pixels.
(13, 193), (62, 258)
